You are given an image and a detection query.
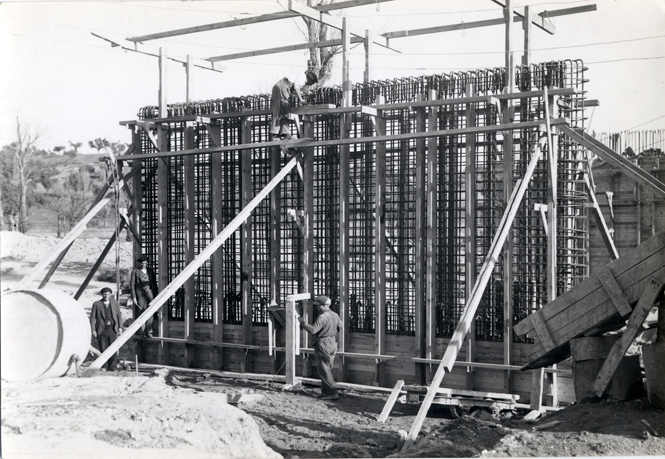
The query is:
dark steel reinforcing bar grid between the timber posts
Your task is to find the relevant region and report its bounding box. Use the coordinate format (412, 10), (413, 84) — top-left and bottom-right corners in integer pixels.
(134, 60), (588, 341)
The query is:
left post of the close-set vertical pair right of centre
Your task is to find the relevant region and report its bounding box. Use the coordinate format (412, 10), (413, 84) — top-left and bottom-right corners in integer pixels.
(414, 94), (428, 384)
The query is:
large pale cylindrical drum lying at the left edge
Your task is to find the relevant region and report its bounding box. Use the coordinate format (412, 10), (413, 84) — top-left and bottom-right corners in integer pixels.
(0, 289), (90, 381)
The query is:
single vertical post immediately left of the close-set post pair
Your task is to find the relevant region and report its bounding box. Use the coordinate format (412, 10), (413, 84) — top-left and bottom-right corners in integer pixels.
(374, 95), (386, 382)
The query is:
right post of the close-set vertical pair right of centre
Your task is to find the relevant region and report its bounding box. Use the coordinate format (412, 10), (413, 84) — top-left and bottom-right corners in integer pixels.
(423, 89), (439, 384)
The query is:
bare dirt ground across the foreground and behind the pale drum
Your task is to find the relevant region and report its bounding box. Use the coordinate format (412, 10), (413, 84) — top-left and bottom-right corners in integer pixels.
(0, 233), (665, 459)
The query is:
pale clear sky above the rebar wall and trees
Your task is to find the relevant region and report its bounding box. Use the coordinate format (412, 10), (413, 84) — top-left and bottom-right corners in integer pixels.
(0, 0), (665, 153)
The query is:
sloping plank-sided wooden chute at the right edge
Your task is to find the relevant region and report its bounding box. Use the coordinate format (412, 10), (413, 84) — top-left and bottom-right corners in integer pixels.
(514, 233), (665, 370)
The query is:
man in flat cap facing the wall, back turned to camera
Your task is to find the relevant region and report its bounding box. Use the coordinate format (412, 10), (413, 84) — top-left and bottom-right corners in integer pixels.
(298, 296), (342, 400)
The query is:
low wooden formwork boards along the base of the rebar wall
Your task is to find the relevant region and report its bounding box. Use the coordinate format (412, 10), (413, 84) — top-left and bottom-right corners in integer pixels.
(143, 322), (575, 403)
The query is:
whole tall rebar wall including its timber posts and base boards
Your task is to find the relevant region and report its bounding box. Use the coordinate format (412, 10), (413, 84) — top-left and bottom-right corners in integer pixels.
(114, 60), (588, 406)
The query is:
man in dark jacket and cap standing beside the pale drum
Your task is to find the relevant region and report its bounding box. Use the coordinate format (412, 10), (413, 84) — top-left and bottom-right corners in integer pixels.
(90, 287), (122, 371)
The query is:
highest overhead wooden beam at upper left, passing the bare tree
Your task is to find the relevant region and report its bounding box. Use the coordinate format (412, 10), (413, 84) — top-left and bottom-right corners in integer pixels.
(127, 0), (392, 43)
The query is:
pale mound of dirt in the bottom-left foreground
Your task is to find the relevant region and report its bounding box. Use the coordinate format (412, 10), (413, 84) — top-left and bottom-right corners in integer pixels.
(2, 372), (281, 459)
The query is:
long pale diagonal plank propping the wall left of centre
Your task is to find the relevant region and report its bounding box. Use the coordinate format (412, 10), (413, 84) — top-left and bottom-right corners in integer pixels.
(83, 156), (298, 377)
